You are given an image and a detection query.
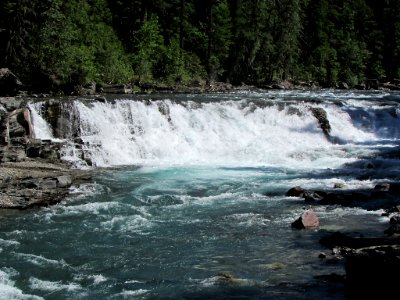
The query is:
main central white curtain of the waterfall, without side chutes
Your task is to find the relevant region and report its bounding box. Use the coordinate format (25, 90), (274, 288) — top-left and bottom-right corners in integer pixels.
(57, 100), (344, 166)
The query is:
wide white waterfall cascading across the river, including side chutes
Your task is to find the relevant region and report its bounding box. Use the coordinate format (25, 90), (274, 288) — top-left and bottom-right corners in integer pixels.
(30, 93), (399, 168)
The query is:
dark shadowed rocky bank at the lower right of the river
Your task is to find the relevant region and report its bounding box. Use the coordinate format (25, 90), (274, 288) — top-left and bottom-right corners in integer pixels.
(286, 182), (400, 299)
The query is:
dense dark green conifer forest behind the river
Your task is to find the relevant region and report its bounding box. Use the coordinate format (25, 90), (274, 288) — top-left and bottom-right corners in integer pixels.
(0, 0), (400, 88)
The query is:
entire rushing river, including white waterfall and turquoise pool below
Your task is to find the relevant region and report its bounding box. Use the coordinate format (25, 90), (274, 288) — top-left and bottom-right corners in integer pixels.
(0, 91), (400, 299)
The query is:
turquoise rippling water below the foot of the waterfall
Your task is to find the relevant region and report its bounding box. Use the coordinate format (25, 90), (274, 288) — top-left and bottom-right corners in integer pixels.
(0, 167), (388, 299)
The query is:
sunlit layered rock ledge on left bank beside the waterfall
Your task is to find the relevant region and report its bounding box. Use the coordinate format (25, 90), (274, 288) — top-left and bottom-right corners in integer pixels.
(0, 98), (90, 209)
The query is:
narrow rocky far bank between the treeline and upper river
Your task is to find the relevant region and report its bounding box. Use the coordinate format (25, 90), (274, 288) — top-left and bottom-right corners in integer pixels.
(0, 68), (400, 97)
